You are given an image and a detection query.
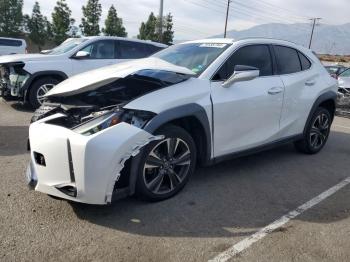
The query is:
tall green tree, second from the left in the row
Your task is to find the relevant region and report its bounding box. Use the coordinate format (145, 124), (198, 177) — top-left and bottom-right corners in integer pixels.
(25, 2), (48, 51)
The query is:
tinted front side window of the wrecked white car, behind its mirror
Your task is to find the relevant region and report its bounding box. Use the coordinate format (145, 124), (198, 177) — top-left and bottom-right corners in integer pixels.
(213, 45), (273, 80)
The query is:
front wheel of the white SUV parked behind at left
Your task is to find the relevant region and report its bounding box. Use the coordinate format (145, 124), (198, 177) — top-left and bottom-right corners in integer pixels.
(29, 77), (60, 109)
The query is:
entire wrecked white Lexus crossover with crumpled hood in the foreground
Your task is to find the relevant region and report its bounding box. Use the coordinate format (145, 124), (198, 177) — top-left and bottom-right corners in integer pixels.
(27, 38), (337, 204)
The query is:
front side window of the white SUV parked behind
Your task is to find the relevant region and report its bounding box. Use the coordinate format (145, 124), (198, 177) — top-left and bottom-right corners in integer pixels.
(80, 40), (115, 59)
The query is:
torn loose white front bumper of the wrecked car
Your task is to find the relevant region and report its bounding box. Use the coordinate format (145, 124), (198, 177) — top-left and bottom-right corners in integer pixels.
(26, 114), (158, 204)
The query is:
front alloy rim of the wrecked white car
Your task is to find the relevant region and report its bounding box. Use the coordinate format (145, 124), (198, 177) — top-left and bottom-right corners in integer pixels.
(143, 138), (191, 195)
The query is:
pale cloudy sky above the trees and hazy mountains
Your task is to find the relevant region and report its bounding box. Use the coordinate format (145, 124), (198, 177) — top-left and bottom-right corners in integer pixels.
(23, 0), (350, 40)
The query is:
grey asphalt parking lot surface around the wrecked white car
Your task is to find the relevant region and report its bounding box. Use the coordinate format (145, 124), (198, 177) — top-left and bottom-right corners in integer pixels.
(0, 101), (350, 261)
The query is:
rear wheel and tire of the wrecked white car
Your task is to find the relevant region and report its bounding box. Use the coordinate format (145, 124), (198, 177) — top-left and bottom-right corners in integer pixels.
(294, 107), (332, 155)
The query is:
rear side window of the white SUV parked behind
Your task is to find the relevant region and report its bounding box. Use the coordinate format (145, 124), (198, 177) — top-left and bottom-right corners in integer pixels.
(118, 41), (151, 59)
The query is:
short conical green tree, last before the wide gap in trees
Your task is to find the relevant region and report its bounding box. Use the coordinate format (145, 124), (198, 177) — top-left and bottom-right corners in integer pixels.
(102, 5), (128, 37)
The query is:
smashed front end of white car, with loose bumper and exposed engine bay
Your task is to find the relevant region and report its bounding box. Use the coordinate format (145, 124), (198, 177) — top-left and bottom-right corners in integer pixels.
(27, 70), (189, 204)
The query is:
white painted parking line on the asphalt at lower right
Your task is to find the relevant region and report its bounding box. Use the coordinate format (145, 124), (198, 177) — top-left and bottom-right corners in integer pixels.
(209, 177), (350, 262)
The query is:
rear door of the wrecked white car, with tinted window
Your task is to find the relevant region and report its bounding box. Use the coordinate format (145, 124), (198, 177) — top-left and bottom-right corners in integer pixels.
(273, 45), (319, 137)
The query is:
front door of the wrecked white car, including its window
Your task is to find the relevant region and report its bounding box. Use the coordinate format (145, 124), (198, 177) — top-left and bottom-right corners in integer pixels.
(211, 45), (284, 156)
